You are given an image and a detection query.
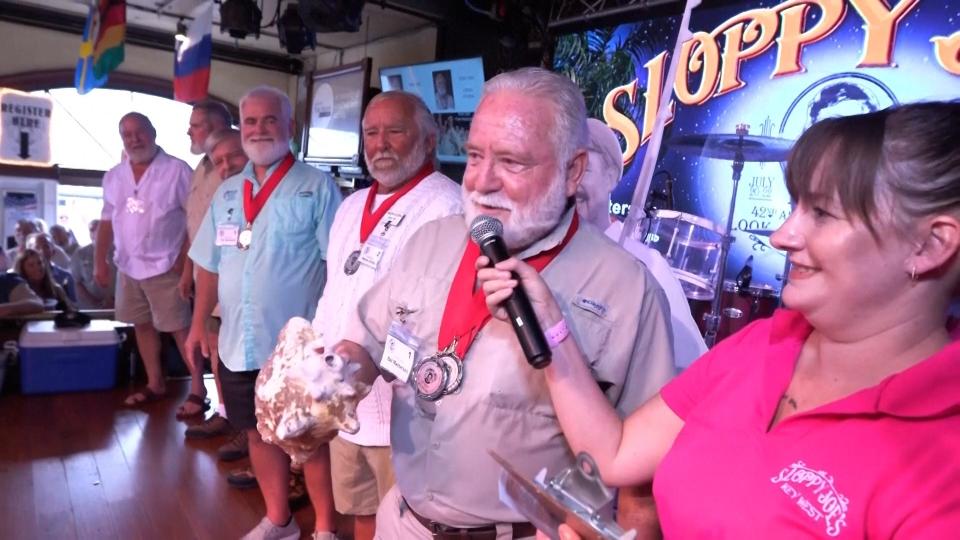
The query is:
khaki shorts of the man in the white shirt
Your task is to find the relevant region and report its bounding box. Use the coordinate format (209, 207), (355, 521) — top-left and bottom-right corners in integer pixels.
(330, 437), (394, 516)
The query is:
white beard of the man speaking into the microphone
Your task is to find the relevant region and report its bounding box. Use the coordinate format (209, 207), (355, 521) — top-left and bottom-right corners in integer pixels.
(461, 171), (567, 252)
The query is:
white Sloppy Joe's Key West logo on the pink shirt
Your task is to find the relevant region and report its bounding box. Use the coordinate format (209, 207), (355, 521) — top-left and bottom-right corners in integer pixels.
(770, 461), (850, 536)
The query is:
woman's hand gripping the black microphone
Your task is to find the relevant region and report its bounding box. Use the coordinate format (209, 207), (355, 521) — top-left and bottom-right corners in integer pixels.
(476, 255), (563, 329)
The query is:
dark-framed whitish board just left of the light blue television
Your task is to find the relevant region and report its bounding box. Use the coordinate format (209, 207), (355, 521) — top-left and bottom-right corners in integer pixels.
(303, 60), (370, 167)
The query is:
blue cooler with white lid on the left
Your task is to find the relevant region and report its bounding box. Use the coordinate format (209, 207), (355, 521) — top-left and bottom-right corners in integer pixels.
(20, 320), (127, 394)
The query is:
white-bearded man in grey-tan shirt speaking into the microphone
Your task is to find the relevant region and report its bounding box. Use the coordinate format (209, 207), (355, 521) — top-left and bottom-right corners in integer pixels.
(336, 68), (674, 539)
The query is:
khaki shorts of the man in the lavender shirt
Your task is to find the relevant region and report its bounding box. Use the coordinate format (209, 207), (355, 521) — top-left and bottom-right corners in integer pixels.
(115, 269), (190, 332)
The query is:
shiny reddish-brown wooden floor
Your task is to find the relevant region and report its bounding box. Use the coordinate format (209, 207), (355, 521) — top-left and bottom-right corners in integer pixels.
(0, 380), (343, 540)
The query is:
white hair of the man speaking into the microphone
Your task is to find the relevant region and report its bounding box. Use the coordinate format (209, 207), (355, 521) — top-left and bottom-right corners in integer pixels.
(481, 68), (587, 169)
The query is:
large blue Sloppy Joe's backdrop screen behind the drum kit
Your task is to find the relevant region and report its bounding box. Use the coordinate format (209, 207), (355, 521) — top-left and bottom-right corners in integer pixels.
(554, 0), (960, 291)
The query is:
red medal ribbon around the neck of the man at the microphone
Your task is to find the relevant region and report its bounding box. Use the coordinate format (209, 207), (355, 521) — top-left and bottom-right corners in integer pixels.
(437, 212), (580, 360)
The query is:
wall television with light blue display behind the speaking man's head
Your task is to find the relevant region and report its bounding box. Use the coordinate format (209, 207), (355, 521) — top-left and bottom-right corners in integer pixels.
(380, 58), (484, 163)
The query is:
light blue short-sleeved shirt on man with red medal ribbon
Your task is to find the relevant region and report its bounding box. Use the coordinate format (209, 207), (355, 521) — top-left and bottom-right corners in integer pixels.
(189, 161), (340, 371)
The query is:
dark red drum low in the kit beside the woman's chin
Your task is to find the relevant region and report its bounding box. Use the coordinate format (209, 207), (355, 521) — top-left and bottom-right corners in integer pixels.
(690, 280), (780, 342)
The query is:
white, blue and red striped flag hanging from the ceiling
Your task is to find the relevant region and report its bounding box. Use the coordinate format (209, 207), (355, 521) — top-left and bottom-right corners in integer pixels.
(173, 0), (213, 103)
